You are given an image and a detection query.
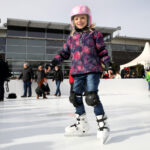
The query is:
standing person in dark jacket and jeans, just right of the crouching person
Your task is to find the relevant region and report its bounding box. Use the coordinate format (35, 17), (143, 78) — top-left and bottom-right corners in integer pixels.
(52, 66), (63, 96)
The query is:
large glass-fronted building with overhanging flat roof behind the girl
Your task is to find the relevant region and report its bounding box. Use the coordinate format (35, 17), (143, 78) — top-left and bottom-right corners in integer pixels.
(0, 19), (118, 77)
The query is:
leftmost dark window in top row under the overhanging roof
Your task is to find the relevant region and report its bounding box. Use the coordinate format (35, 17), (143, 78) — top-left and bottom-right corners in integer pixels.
(7, 26), (26, 36)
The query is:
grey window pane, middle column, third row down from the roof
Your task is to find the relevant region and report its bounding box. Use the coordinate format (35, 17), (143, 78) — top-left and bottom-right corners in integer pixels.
(27, 47), (45, 54)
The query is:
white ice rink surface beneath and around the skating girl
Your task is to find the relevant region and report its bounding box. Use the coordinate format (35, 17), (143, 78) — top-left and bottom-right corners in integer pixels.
(0, 80), (150, 150)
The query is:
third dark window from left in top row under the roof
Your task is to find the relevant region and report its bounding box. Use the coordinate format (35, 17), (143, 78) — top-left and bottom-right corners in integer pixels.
(47, 29), (63, 39)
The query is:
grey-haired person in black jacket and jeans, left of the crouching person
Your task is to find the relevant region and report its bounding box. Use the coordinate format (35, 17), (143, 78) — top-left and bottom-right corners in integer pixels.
(18, 63), (33, 97)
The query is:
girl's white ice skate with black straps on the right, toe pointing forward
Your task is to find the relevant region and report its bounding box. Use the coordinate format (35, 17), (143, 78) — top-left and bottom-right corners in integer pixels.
(96, 115), (110, 144)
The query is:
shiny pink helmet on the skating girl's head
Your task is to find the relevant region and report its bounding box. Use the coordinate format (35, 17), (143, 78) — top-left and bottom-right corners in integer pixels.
(70, 5), (92, 27)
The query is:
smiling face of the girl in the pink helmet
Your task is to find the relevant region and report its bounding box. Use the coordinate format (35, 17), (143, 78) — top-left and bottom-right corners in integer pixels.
(73, 15), (88, 29)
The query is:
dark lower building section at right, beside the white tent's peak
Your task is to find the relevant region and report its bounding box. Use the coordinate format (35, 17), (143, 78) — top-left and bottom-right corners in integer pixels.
(111, 36), (150, 65)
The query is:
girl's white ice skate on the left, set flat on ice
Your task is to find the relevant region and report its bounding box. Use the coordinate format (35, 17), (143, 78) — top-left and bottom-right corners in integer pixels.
(65, 114), (89, 136)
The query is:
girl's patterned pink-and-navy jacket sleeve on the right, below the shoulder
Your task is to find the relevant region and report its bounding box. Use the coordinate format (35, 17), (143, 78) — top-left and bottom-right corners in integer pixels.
(94, 31), (110, 65)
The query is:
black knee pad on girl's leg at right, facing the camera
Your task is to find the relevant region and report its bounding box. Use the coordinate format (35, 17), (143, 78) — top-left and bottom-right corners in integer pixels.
(85, 91), (100, 106)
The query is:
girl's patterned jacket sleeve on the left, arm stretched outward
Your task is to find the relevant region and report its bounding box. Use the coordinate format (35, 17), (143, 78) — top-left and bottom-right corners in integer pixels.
(52, 37), (70, 66)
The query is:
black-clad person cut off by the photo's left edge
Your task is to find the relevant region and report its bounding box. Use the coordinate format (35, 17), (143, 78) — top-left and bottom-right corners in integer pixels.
(0, 57), (10, 101)
